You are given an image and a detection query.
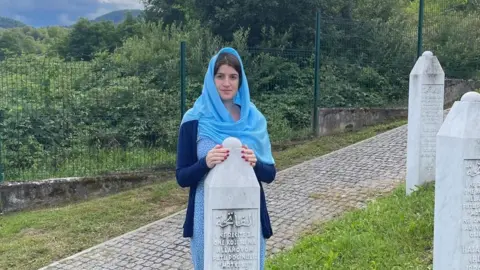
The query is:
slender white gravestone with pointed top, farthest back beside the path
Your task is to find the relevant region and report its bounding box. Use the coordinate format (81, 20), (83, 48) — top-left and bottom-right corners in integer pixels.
(406, 51), (445, 195)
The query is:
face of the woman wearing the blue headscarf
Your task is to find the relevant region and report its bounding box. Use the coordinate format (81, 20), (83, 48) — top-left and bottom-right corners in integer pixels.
(215, 65), (239, 101)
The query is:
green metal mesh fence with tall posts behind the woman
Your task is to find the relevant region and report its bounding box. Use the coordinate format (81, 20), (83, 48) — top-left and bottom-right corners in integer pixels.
(0, 3), (480, 181)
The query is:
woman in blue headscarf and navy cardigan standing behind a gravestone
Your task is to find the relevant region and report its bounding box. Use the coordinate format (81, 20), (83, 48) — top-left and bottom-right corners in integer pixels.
(176, 48), (276, 269)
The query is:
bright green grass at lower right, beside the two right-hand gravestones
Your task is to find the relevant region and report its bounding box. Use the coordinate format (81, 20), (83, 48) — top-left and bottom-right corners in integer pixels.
(267, 184), (434, 270)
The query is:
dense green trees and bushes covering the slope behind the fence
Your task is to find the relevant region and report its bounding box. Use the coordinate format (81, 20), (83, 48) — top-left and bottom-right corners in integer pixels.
(0, 0), (480, 179)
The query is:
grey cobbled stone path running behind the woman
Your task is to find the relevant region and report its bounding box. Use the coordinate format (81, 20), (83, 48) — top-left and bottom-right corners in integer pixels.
(42, 123), (407, 270)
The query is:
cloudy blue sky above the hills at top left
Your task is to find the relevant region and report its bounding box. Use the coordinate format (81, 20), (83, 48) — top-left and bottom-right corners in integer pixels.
(0, 0), (143, 27)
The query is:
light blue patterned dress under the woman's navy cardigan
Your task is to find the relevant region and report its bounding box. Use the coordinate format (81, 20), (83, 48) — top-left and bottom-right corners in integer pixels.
(190, 138), (266, 270)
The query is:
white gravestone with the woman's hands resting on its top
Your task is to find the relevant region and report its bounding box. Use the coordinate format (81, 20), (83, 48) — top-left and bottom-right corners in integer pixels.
(204, 138), (261, 270)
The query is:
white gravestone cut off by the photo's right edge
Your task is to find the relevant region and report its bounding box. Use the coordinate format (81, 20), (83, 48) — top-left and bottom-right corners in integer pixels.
(433, 92), (480, 270)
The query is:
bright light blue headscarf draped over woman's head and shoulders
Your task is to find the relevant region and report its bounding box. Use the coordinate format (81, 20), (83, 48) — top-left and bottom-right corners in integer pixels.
(182, 47), (275, 164)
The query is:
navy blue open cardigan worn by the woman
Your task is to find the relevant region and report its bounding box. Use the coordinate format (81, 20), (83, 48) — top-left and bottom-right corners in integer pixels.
(176, 120), (276, 238)
